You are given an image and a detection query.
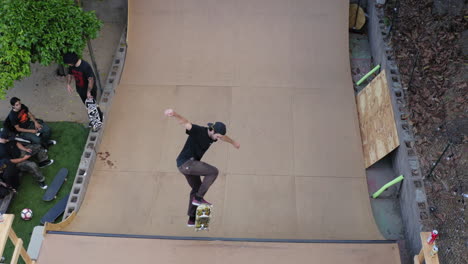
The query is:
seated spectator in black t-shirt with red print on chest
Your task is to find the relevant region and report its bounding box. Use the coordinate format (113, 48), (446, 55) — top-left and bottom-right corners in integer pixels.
(8, 97), (57, 148)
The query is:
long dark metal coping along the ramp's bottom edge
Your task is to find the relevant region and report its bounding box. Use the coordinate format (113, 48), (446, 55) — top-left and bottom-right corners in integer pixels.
(47, 231), (397, 244)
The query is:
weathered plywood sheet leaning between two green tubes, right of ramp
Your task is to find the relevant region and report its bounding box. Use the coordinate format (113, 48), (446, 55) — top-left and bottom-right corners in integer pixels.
(356, 71), (400, 168)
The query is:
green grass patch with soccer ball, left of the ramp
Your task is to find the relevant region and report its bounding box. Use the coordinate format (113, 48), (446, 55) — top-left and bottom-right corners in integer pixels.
(3, 122), (89, 263)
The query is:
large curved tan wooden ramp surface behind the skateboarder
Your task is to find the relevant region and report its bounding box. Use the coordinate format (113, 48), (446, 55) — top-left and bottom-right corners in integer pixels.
(67, 0), (384, 241)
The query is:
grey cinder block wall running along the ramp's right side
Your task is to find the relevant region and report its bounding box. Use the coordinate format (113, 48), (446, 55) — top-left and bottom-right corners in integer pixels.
(367, 0), (428, 254)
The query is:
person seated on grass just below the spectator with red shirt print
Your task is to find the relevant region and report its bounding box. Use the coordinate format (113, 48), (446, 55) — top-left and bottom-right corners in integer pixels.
(0, 131), (54, 190)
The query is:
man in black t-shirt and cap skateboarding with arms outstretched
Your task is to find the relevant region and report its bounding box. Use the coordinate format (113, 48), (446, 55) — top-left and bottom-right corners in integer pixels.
(164, 109), (240, 227)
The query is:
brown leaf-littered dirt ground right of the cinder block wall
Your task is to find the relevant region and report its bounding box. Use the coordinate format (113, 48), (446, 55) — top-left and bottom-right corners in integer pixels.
(385, 0), (468, 264)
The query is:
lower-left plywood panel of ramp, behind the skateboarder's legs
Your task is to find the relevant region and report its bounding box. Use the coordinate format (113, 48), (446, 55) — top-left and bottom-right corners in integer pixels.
(67, 171), (226, 236)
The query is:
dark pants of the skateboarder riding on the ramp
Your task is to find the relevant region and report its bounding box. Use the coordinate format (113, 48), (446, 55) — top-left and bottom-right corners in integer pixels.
(179, 160), (218, 217)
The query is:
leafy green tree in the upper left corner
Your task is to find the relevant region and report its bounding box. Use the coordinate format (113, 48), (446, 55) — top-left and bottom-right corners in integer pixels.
(0, 0), (102, 98)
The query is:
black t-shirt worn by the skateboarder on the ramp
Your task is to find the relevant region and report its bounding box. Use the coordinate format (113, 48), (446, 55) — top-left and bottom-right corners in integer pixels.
(177, 124), (215, 167)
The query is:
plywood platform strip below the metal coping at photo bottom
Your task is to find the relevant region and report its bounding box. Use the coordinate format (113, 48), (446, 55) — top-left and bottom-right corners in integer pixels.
(37, 234), (399, 264)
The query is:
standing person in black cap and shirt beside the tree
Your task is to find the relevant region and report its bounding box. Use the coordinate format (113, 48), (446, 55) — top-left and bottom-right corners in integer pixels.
(63, 53), (102, 125)
